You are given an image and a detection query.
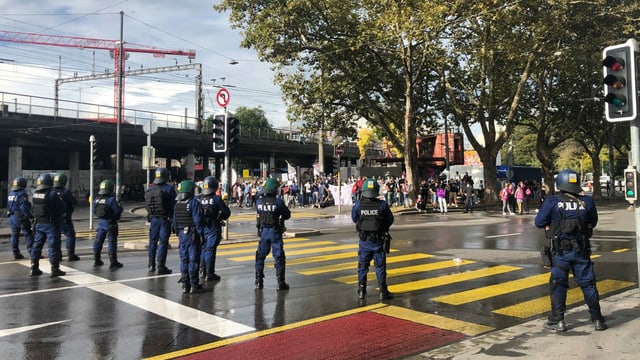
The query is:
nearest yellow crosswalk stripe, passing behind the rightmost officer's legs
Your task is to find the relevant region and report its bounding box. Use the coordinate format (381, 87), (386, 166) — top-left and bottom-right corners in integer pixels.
(493, 279), (636, 319)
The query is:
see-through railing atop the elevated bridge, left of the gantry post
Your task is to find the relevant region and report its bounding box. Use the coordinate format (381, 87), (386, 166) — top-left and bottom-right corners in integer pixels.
(0, 91), (197, 130)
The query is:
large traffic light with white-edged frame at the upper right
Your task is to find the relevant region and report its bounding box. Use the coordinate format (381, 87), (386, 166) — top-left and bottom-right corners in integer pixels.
(602, 39), (638, 122)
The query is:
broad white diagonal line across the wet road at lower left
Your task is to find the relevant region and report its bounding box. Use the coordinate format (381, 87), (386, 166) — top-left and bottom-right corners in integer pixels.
(13, 260), (255, 337)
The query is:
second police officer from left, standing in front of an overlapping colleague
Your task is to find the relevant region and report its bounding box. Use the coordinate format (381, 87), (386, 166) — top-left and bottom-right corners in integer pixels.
(30, 173), (66, 277)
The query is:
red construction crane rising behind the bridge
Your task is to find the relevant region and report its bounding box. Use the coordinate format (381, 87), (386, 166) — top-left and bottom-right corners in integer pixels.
(0, 30), (196, 116)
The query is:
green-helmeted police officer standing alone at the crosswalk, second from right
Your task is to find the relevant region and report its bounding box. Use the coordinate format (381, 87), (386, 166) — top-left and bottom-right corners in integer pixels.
(351, 178), (394, 300)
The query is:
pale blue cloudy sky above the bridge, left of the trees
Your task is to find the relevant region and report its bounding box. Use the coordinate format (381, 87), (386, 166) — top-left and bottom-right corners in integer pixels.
(0, 0), (289, 127)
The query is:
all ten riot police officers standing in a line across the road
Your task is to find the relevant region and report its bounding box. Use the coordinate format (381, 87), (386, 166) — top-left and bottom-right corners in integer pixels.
(7, 168), (607, 331)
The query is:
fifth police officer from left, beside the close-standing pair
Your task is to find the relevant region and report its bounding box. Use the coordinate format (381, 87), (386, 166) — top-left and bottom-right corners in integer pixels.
(144, 168), (178, 275)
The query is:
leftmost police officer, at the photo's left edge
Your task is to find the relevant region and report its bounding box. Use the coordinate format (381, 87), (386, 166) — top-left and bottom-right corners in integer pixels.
(7, 176), (33, 260)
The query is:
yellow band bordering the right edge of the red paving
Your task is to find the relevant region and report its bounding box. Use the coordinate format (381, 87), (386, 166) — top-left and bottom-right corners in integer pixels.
(372, 305), (494, 336)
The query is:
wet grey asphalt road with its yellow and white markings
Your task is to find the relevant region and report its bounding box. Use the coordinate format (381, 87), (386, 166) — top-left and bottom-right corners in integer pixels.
(0, 201), (637, 359)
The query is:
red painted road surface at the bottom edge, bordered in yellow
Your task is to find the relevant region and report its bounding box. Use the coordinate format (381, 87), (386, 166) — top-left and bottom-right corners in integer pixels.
(175, 312), (466, 360)
